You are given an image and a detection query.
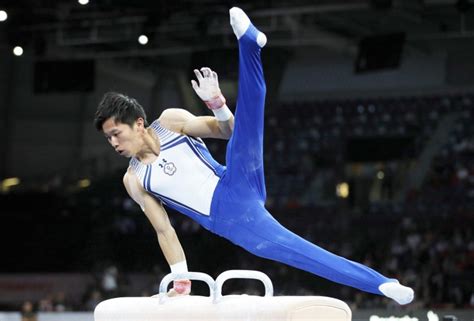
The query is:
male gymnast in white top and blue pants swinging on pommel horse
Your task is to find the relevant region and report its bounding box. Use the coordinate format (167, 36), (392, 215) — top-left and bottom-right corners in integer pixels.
(94, 7), (414, 304)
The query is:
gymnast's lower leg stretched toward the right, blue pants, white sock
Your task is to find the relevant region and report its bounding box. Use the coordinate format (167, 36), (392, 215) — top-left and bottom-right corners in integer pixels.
(227, 206), (413, 304)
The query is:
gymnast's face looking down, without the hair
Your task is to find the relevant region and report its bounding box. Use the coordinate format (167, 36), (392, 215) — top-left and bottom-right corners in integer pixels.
(102, 118), (144, 157)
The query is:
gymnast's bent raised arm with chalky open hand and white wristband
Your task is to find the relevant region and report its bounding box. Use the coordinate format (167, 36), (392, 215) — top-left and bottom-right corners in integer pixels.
(159, 67), (234, 139)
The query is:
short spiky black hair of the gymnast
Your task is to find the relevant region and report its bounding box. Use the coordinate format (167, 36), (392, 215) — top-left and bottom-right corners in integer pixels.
(94, 92), (148, 131)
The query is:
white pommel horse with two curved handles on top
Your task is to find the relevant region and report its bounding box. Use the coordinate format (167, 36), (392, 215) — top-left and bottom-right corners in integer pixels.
(94, 270), (352, 321)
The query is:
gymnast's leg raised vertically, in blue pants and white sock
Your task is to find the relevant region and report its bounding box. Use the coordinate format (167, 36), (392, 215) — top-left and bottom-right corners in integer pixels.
(226, 8), (266, 200)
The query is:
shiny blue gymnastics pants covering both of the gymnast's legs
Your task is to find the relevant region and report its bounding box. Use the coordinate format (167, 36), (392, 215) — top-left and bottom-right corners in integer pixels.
(210, 25), (394, 294)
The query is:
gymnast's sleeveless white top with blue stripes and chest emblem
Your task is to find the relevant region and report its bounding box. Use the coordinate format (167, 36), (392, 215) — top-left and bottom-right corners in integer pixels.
(130, 120), (224, 215)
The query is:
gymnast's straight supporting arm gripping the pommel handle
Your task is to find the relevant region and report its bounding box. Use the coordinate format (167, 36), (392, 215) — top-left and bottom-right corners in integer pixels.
(123, 169), (191, 295)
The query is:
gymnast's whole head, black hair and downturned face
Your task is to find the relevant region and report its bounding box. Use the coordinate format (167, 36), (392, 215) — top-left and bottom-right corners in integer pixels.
(94, 92), (148, 157)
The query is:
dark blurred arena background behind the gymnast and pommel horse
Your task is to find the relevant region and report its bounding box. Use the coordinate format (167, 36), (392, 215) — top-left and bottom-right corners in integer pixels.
(0, 0), (474, 321)
